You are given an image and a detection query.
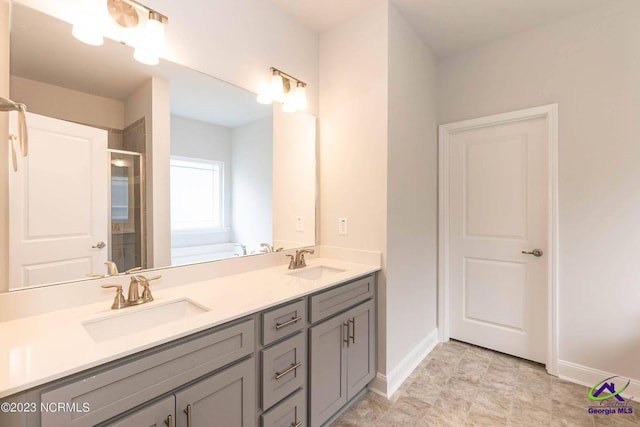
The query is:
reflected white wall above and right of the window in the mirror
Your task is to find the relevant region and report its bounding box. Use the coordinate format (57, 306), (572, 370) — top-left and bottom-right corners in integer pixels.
(171, 115), (233, 237)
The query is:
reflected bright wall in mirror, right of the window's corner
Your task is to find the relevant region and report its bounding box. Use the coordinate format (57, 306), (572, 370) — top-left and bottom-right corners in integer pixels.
(231, 117), (273, 249)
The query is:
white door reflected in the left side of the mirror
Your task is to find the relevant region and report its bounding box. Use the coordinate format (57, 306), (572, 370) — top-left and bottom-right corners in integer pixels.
(9, 113), (109, 289)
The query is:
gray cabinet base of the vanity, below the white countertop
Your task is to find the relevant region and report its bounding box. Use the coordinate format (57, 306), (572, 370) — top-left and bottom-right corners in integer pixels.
(0, 274), (376, 427)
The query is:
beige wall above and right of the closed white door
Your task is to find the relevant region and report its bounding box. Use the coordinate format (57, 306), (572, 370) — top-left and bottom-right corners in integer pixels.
(438, 0), (640, 379)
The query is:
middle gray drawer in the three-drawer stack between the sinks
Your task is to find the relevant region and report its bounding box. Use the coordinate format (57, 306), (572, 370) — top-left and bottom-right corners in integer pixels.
(262, 334), (307, 410)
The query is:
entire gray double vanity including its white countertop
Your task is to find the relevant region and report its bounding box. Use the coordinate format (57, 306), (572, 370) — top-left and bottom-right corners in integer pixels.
(0, 258), (379, 427)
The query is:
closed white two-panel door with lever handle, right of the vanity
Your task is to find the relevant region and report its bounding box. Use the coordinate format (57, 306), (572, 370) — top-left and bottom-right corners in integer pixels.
(448, 118), (548, 362)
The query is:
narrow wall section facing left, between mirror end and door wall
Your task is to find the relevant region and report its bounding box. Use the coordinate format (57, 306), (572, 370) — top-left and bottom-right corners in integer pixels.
(386, 5), (438, 382)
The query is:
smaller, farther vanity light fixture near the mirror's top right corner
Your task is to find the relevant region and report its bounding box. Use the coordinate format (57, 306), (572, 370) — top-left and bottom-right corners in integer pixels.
(257, 67), (307, 113)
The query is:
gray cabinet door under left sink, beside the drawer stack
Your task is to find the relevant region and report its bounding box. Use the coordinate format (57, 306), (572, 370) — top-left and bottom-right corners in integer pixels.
(176, 357), (256, 427)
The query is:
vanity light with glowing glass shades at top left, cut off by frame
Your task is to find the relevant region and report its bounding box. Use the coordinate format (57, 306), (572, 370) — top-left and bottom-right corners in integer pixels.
(72, 0), (169, 65)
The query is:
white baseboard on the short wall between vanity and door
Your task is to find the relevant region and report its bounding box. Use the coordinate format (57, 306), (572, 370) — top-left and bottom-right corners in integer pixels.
(369, 328), (439, 399)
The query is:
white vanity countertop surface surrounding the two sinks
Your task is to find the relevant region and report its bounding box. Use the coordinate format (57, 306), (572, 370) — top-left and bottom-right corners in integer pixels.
(0, 258), (380, 398)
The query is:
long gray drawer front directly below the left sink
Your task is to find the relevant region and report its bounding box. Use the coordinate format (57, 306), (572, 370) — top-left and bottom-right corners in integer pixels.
(41, 320), (255, 427)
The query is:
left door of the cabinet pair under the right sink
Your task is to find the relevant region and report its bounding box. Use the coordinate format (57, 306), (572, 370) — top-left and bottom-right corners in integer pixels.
(309, 315), (347, 426)
